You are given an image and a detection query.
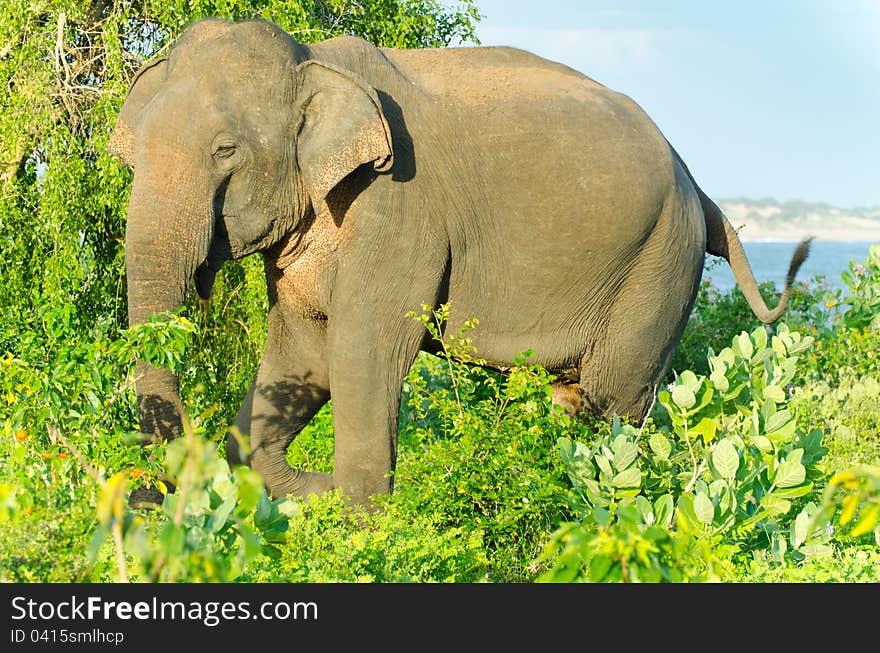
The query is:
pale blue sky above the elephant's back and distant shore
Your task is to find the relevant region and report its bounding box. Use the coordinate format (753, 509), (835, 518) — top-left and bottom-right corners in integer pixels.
(464, 0), (880, 208)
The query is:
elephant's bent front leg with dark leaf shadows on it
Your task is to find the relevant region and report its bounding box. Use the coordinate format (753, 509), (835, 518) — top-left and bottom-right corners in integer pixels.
(235, 322), (333, 497)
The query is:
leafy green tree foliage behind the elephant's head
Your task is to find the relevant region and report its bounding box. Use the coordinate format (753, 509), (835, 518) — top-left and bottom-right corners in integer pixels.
(0, 0), (478, 344)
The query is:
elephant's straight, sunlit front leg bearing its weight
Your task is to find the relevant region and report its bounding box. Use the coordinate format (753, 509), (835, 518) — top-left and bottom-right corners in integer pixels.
(327, 242), (445, 507)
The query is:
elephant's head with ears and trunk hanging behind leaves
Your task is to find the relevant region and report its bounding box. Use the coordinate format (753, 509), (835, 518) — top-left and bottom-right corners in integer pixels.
(109, 19), (392, 444)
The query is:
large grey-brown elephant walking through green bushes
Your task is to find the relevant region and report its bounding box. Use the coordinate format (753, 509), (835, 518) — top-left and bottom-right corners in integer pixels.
(108, 18), (809, 506)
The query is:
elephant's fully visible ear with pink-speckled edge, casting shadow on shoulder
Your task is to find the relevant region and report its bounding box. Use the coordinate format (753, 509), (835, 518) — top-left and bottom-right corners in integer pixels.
(295, 60), (394, 215)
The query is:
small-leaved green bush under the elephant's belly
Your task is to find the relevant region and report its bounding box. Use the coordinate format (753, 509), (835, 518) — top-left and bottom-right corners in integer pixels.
(394, 307), (583, 582)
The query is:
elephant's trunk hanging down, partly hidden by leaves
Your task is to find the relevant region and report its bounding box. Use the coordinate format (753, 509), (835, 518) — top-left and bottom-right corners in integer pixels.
(125, 174), (213, 441)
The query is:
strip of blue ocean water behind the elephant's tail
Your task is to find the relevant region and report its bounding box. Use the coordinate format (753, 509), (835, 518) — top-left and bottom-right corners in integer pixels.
(703, 240), (872, 291)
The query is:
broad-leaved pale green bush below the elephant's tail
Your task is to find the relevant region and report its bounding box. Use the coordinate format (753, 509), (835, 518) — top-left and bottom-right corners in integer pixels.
(543, 324), (825, 581)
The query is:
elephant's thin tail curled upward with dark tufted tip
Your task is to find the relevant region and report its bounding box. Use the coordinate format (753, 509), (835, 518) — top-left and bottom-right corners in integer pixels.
(694, 184), (813, 324)
